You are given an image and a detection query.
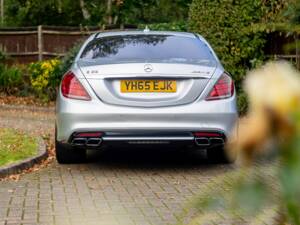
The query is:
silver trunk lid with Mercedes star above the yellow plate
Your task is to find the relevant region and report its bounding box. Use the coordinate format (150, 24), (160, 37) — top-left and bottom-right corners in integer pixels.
(78, 63), (216, 107)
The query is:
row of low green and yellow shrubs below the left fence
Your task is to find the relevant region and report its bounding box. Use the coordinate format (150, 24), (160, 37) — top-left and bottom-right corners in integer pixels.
(0, 42), (82, 102)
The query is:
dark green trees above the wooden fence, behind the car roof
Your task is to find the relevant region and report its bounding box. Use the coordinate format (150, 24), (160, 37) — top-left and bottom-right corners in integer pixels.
(5, 0), (191, 26)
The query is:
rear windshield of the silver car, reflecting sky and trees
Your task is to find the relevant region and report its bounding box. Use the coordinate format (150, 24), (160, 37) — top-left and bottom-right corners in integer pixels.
(81, 34), (215, 65)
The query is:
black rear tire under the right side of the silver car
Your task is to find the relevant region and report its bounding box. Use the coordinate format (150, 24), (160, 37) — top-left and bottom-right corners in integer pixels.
(206, 147), (236, 164)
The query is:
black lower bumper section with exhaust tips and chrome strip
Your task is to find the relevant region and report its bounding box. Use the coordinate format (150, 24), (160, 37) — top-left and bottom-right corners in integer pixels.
(67, 131), (226, 149)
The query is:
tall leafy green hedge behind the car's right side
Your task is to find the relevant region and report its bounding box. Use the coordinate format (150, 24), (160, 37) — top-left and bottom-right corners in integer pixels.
(189, 0), (283, 113)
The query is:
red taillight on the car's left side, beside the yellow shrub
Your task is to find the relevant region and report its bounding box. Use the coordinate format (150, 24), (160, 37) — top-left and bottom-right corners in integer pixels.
(61, 71), (91, 101)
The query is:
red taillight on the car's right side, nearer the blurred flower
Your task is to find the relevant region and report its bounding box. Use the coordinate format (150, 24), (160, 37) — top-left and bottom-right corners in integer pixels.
(206, 73), (234, 101)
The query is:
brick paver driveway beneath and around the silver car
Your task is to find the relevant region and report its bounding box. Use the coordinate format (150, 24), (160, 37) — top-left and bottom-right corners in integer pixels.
(0, 108), (232, 225)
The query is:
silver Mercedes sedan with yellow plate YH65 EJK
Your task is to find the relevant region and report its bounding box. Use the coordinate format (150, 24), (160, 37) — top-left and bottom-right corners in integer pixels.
(55, 30), (238, 163)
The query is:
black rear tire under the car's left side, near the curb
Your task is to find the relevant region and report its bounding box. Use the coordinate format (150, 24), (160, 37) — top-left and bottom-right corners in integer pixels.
(55, 141), (86, 164)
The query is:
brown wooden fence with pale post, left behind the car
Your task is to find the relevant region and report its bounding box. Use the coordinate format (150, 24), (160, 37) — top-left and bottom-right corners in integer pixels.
(0, 25), (136, 64)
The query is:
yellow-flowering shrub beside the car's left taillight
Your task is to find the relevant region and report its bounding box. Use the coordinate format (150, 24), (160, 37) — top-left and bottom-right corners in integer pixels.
(28, 59), (62, 101)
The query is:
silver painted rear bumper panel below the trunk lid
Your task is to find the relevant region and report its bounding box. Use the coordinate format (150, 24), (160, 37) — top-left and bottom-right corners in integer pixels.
(56, 93), (238, 144)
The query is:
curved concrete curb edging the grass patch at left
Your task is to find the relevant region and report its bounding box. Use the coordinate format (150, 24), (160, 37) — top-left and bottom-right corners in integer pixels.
(0, 137), (48, 178)
